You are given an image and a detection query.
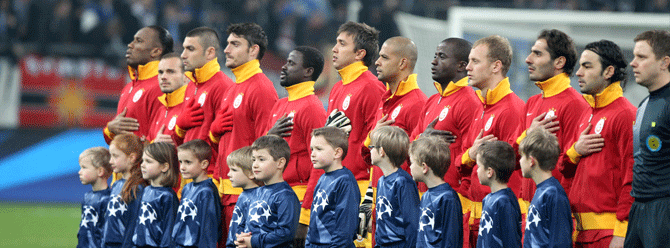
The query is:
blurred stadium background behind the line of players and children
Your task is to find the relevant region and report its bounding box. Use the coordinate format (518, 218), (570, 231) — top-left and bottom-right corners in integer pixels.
(0, 0), (670, 247)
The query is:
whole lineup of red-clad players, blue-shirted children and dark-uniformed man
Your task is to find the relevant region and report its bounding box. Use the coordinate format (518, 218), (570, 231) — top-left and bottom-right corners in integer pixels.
(77, 19), (670, 248)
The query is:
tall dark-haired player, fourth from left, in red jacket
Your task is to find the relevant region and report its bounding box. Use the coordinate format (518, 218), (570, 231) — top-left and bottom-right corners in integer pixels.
(209, 23), (277, 244)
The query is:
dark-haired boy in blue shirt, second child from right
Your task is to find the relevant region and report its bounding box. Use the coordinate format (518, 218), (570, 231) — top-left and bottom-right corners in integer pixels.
(476, 140), (521, 248)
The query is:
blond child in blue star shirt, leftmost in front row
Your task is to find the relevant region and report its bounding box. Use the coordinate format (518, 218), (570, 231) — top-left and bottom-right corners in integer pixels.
(77, 147), (112, 247)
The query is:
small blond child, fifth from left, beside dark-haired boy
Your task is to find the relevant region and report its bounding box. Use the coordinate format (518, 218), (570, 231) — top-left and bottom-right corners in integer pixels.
(226, 146), (263, 247)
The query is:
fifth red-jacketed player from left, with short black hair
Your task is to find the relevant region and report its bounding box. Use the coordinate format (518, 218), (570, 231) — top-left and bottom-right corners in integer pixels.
(265, 46), (327, 245)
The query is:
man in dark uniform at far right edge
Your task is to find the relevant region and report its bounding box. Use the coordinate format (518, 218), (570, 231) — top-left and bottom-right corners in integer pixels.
(624, 30), (670, 247)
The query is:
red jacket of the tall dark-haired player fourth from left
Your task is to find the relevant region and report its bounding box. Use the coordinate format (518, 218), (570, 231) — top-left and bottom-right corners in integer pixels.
(210, 60), (278, 205)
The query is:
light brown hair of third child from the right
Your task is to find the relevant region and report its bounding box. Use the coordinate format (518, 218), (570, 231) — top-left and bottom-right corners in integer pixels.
(409, 136), (451, 178)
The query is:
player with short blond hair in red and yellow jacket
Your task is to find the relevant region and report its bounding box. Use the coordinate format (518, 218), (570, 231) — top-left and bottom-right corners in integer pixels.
(456, 35), (523, 246)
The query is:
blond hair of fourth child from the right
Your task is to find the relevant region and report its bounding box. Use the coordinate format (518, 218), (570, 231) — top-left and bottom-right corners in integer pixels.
(370, 126), (409, 167)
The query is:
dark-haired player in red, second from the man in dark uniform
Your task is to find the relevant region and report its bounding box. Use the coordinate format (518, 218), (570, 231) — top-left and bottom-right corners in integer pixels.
(514, 29), (588, 223)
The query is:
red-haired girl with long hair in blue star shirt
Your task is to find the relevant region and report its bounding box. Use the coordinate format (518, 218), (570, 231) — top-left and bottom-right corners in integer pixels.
(102, 134), (147, 247)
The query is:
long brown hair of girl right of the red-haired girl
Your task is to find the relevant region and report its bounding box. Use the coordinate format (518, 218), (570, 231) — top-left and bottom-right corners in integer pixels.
(144, 142), (179, 188)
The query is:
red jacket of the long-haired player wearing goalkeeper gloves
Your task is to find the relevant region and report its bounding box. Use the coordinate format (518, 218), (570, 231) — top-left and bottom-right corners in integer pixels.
(326, 61), (385, 183)
